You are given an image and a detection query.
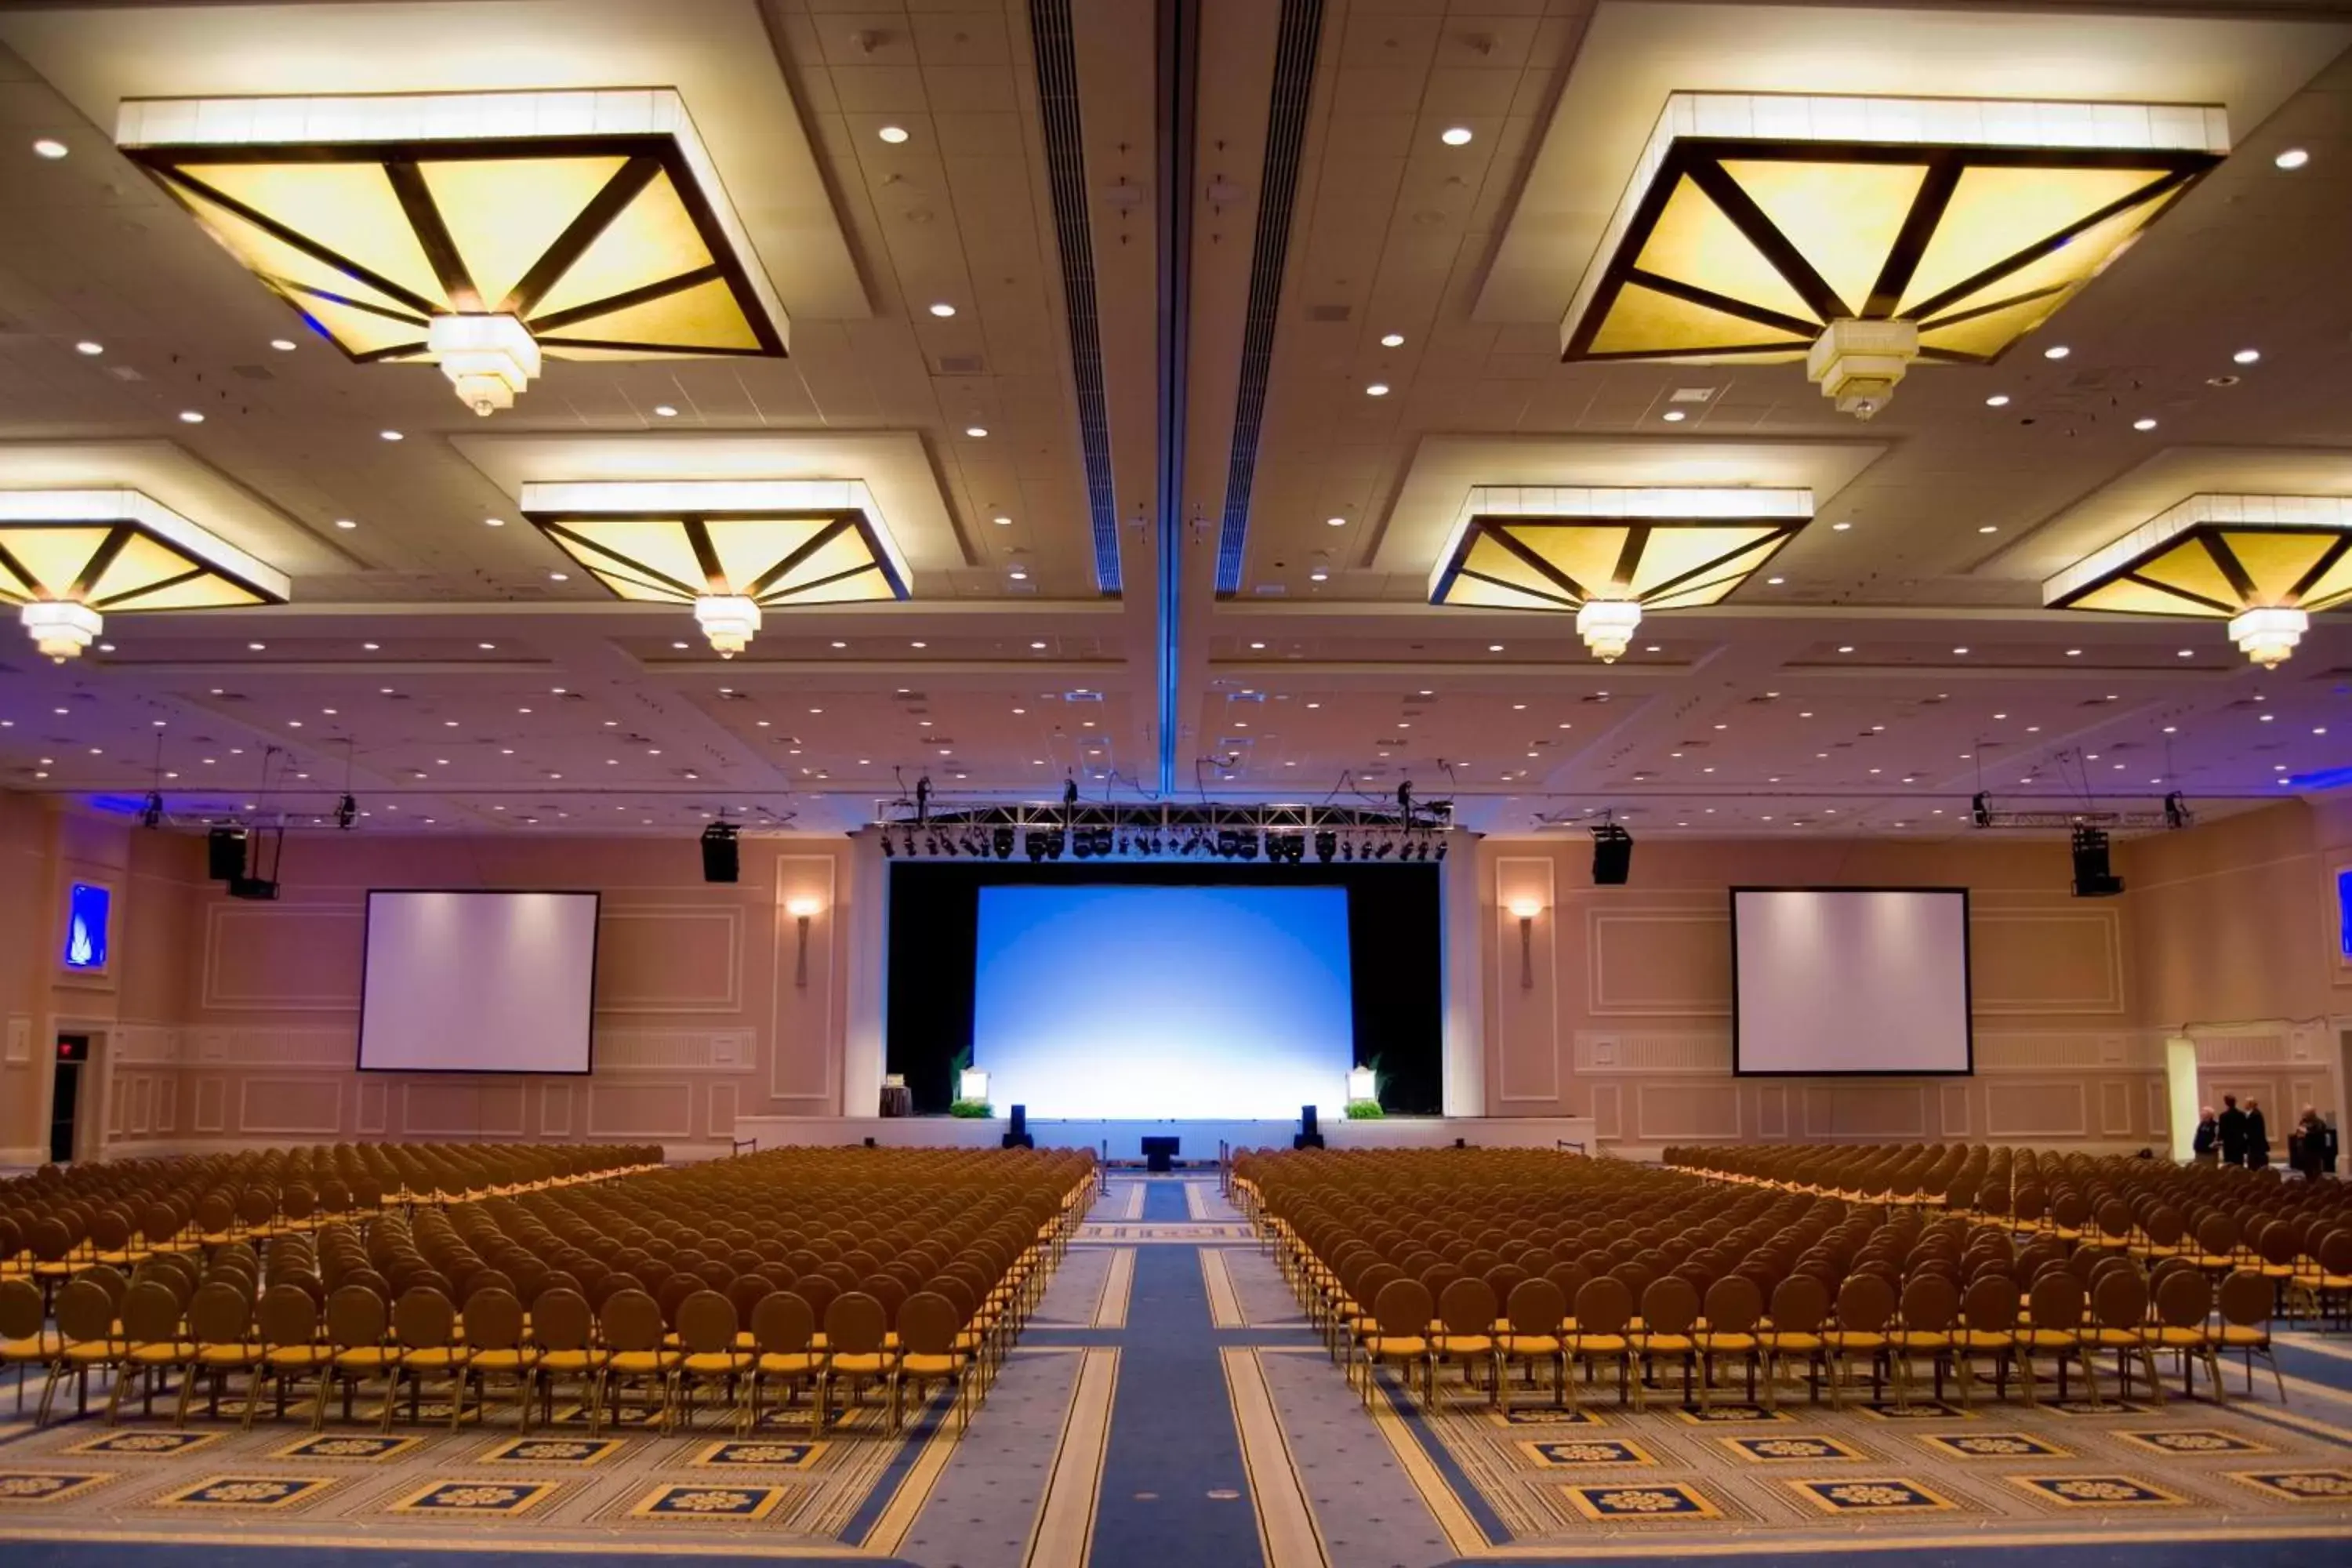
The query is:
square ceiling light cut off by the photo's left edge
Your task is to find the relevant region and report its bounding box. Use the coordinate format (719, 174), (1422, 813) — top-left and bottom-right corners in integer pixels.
(0, 489), (289, 663)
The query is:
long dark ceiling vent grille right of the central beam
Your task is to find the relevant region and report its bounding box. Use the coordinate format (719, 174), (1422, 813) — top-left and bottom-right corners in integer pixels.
(1216, 0), (1322, 600)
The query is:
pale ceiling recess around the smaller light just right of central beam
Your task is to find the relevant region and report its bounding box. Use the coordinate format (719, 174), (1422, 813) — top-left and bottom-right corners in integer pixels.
(1374, 435), (1889, 576)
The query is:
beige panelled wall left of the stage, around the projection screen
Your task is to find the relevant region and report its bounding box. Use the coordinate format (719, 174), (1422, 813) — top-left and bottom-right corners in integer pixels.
(0, 799), (870, 1159)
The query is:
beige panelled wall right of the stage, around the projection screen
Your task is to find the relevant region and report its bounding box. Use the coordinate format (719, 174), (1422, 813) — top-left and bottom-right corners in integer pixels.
(1479, 801), (2352, 1152)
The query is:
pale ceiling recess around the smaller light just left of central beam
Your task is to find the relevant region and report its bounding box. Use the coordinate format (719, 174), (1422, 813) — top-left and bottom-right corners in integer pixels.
(449, 433), (964, 585)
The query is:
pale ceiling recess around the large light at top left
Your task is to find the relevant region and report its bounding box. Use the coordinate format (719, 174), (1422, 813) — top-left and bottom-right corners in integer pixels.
(0, 0), (873, 320)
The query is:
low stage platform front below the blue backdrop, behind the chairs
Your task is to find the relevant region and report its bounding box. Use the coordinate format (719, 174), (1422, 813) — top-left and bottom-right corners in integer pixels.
(734, 1116), (1592, 1161)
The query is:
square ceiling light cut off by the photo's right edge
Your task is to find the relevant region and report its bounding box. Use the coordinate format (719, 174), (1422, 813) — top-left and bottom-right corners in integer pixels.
(2042, 496), (2352, 670)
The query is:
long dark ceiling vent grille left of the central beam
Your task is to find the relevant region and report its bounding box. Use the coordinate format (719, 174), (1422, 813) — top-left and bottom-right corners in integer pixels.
(1030, 0), (1120, 595)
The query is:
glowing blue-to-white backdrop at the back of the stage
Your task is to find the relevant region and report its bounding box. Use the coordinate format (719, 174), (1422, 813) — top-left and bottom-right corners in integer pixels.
(971, 886), (1355, 1119)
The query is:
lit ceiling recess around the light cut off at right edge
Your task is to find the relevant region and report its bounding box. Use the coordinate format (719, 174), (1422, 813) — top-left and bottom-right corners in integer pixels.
(1978, 447), (2352, 583)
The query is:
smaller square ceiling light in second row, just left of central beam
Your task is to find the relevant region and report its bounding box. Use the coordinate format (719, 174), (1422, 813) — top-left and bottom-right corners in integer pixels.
(522, 480), (908, 659)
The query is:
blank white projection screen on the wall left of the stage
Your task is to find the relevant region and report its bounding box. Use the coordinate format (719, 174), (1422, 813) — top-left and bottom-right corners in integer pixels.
(360, 891), (597, 1074)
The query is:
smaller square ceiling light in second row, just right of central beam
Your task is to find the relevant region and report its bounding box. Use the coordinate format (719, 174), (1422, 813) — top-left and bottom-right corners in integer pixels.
(1430, 485), (1813, 663)
